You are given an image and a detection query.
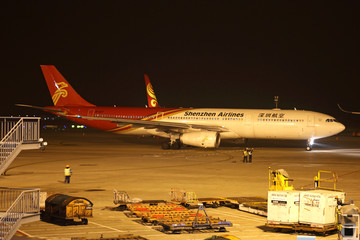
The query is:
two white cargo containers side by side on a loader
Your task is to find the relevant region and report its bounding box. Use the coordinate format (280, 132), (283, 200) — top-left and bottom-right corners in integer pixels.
(266, 170), (345, 234)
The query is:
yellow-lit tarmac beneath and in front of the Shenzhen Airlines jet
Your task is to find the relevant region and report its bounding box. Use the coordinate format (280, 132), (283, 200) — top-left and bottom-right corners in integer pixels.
(0, 130), (360, 240)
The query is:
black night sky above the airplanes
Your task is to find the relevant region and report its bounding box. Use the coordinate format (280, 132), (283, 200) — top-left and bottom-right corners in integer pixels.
(0, 0), (360, 125)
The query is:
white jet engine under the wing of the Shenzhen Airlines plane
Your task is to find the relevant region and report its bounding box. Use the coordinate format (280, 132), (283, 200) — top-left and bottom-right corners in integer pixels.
(180, 131), (220, 148)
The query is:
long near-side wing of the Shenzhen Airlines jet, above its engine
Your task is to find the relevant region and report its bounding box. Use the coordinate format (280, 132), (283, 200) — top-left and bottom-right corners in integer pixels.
(73, 115), (229, 132)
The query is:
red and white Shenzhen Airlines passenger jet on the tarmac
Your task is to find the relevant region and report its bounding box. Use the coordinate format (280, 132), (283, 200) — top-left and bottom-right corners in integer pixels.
(18, 65), (345, 151)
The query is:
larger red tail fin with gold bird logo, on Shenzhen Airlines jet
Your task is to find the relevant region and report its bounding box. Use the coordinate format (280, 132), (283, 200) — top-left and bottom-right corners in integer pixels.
(41, 65), (95, 107)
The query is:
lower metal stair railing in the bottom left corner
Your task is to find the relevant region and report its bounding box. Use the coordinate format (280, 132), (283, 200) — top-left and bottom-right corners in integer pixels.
(0, 188), (40, 240)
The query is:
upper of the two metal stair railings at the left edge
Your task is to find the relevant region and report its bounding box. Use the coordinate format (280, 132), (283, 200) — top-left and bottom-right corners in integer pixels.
(0, 117), (40, 172)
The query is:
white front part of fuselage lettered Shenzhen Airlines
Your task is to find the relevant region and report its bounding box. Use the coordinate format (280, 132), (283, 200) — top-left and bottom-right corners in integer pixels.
(145, 108), (345, 140)
